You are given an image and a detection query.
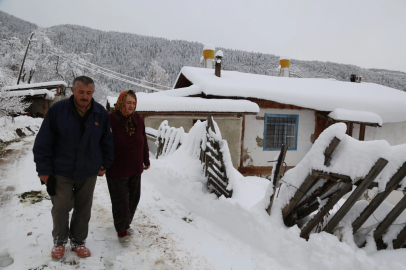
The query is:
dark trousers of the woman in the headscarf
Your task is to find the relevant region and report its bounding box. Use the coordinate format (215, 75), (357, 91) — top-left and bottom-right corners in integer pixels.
(107, 175), (141, 234)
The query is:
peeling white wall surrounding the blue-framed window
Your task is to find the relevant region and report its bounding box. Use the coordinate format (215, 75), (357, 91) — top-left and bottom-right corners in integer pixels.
(244, 108), (315, 167)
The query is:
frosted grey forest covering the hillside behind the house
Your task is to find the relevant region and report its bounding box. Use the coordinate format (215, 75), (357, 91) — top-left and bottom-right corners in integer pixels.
(0, 11), (406, 92)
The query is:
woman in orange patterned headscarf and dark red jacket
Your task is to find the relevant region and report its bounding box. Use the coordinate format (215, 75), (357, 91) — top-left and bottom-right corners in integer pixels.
(106, 90), (150, 243)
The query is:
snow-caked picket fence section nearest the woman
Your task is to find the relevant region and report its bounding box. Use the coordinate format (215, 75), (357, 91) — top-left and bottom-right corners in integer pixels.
(156, 120), (186, 159)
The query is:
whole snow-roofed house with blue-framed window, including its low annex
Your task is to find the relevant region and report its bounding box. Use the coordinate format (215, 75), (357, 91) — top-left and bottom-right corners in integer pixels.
(105, 62), (406, 175)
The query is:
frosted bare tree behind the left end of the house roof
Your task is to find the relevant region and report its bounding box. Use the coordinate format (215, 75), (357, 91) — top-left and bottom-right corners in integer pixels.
(140, 60), (169, 93)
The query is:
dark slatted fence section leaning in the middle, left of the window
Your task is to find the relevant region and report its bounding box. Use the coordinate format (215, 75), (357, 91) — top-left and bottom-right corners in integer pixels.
(200, 115), (233, 198)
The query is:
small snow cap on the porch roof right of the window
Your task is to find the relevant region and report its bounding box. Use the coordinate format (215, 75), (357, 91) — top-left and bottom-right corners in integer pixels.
(328, 108), (382, 126)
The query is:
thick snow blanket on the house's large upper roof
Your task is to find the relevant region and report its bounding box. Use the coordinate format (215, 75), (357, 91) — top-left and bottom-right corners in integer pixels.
(170, 67), (406, 123)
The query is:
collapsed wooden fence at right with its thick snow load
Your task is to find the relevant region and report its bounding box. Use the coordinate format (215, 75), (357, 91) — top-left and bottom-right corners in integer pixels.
(267, 124), (406, 249)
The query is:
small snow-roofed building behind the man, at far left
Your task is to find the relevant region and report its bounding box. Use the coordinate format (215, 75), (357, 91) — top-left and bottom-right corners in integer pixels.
(4, 81), (68, 117)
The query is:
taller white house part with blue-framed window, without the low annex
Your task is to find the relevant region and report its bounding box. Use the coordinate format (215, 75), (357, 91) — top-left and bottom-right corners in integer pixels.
(160, 67), (406, 174)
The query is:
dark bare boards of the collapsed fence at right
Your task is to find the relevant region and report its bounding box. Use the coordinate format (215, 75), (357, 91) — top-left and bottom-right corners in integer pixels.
(266, 137), (406, 249)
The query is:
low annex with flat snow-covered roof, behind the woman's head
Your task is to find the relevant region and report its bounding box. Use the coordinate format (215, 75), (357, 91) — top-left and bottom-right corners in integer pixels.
(106, 93), (259, 168)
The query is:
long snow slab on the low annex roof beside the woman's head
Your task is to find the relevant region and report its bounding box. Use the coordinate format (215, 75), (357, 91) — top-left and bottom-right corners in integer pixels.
(107, 92), (259, 114)
